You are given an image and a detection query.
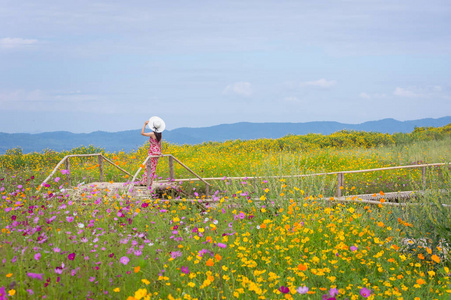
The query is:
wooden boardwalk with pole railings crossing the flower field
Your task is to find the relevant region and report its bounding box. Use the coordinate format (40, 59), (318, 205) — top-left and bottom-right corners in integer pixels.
(41, 153), (451, 206)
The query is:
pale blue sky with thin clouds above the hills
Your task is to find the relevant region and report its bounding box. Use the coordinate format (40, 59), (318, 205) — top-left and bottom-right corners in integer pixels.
(0, 0), (451, 133)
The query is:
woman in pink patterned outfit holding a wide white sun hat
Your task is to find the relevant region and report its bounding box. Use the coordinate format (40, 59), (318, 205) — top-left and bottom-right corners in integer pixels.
(141, 117), (166, 187)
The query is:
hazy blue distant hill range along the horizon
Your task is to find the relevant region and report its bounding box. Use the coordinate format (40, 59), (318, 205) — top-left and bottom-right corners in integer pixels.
(0, 116), (451, 154)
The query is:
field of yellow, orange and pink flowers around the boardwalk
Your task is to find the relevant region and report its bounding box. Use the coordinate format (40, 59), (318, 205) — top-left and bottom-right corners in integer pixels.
(0, 127), (451, 299)
